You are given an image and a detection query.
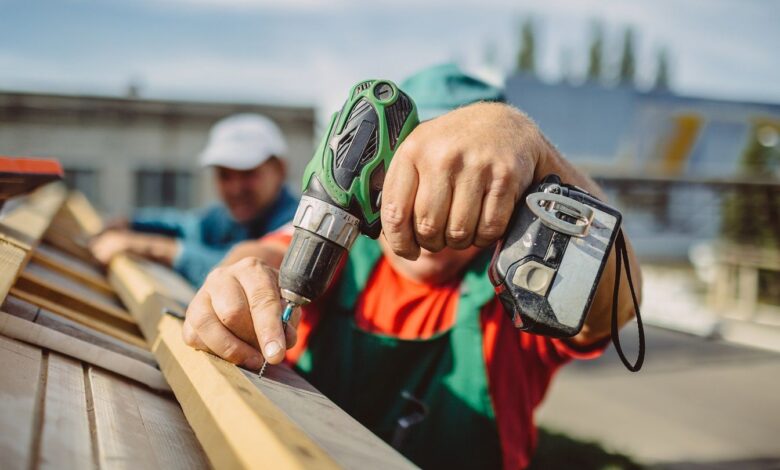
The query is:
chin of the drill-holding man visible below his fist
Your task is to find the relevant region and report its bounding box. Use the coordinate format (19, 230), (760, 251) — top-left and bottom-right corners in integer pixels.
(379, 236), (482, 284)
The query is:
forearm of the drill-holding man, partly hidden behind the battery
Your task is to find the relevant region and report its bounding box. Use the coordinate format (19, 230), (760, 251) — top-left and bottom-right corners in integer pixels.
(520, 109), (642, 345)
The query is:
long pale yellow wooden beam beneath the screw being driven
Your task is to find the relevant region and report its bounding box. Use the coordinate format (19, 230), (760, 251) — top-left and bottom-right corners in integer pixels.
(109, 256), (339, 469)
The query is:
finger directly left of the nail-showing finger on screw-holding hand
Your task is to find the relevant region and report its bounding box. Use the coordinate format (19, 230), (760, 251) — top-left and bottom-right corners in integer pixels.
(207, 269), (260, 349)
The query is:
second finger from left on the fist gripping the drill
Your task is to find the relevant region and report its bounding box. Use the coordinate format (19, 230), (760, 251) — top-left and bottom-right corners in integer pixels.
(414, 174), (452, 252)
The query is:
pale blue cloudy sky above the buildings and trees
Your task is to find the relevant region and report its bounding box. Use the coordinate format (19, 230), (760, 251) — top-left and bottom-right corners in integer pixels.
(0, 0), (780, 113)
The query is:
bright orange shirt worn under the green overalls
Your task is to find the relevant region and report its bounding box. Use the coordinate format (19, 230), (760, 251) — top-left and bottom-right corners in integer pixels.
(269, 231), (609, 468)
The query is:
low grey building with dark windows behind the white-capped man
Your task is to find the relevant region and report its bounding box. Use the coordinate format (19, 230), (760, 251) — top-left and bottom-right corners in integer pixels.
(0, 92), (315, 215)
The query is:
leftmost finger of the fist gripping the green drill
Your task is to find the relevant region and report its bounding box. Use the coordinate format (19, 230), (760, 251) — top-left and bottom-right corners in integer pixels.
(381, 150), (420, 259)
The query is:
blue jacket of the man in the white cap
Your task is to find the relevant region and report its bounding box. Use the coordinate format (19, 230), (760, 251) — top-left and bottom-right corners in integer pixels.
(131, 187), (298, 287)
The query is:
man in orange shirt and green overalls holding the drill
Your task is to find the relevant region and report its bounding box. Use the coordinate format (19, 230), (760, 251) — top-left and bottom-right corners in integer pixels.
(183, 66), (641, 468)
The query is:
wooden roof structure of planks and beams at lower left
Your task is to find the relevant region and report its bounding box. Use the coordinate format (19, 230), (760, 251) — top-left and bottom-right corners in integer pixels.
(0, 184), (412, 468)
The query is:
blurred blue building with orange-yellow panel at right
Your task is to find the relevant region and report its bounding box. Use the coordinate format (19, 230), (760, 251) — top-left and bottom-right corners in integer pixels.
(506, 74), (780, 260)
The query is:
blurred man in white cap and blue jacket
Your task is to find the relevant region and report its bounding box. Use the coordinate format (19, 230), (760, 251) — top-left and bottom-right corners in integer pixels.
(92, 114), (298, 286)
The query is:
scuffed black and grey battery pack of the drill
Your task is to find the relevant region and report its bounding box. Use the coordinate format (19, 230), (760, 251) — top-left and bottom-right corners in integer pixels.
(489, 175), (621, 337)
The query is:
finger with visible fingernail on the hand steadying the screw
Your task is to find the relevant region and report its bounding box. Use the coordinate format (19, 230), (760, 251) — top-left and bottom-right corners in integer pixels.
(235, 258), (286, 364)
